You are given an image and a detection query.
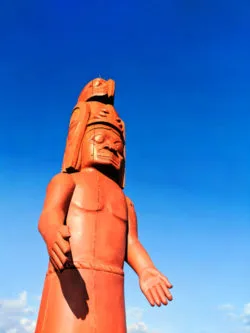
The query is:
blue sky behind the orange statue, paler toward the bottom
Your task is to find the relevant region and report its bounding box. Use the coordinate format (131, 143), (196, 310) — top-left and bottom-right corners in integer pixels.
(0, 0), (250, 333)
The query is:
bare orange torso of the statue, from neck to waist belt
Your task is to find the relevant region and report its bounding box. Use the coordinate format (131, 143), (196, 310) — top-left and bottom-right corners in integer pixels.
(67, 168), (127, 268)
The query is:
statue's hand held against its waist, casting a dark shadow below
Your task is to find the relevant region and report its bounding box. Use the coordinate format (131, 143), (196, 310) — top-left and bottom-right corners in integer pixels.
(46, 225), (70, 271)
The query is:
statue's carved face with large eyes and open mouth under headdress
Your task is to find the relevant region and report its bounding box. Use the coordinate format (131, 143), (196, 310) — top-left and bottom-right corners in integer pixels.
(81, 124), (124, 171)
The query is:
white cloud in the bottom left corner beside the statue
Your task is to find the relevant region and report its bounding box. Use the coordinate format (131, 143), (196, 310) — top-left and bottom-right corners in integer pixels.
(0, 291), (36, 333)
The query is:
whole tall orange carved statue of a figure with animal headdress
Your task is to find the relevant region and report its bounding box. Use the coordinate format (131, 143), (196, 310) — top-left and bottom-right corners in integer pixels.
(35, 78), (172, 333)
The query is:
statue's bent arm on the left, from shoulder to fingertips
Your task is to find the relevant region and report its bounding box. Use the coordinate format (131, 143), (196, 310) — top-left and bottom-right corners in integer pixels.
(38, 173), (75, 270)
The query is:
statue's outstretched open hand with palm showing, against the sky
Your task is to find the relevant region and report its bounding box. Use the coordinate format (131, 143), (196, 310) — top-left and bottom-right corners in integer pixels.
(140, 268), (173, 306)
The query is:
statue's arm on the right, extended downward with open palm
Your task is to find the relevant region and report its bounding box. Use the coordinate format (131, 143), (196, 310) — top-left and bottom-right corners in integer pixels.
(126, 197), (172, 306)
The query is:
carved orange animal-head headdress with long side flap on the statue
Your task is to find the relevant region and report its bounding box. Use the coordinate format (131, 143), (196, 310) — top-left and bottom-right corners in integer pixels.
(62, 78), (125, 188)
